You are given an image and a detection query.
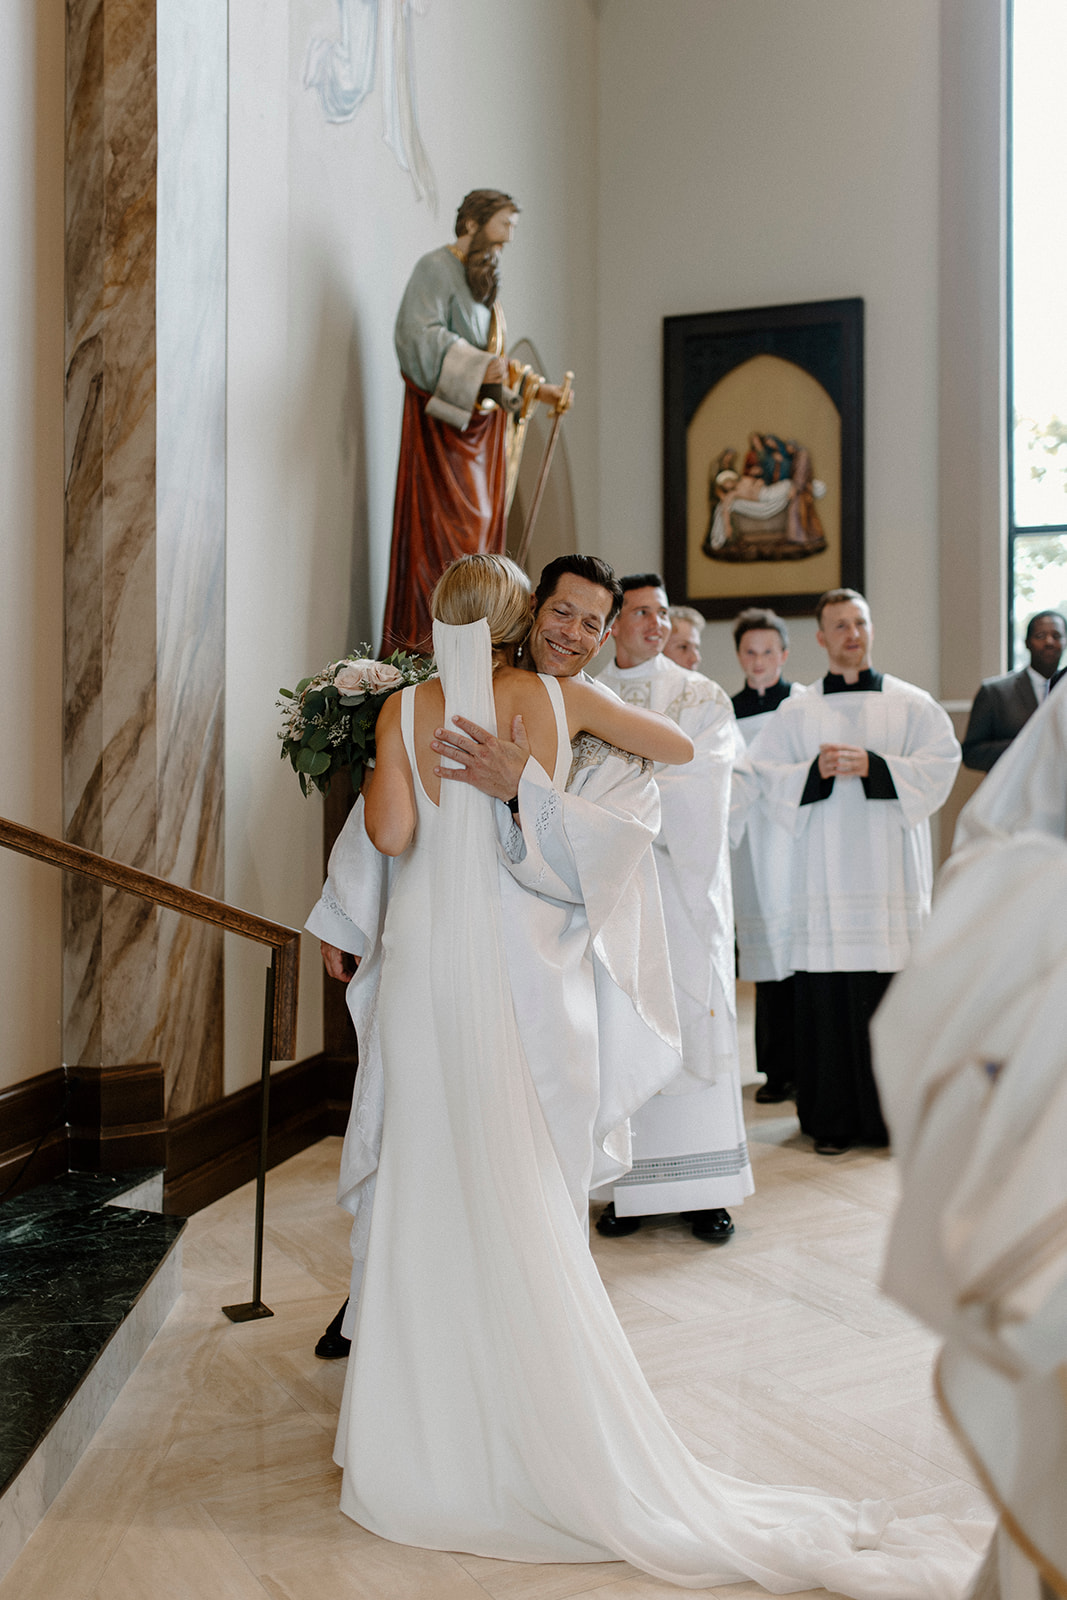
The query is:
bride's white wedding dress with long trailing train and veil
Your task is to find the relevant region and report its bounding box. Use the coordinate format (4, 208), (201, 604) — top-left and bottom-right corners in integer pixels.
(334, 622), (977, 1600)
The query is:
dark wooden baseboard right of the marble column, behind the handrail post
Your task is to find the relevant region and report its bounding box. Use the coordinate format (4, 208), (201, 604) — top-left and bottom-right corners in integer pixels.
(163, 1054), (355, 1216)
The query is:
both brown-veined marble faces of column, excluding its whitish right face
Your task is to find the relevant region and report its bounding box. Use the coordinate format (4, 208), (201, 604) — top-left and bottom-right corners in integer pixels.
(64, 0), (157, 1064)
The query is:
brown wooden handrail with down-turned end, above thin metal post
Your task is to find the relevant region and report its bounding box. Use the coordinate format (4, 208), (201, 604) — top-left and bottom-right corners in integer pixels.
(0, 818), (301, 1061)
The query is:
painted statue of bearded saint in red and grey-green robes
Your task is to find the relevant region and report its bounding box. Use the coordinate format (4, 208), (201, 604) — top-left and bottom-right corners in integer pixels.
(382, 189), (569, 653)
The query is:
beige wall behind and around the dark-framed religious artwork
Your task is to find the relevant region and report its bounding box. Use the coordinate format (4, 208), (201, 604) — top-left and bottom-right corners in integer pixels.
(598, 0), (939, 693)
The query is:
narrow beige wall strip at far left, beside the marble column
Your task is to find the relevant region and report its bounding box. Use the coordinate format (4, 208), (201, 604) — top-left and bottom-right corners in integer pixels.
(0, 0), (64, 1088)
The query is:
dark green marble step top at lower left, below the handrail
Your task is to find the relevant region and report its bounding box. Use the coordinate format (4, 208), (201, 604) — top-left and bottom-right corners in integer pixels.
(0, 1171), (186, 1496)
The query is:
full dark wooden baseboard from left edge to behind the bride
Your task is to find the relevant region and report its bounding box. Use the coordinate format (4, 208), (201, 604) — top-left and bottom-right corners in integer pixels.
(0, 1054), (355, 1216)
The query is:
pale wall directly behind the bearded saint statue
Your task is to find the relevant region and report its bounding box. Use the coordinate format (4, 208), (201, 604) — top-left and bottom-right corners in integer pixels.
(226, 0), (597, 1090)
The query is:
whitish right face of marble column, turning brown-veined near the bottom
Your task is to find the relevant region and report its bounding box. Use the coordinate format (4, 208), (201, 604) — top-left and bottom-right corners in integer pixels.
(155, 0), (227, 1115)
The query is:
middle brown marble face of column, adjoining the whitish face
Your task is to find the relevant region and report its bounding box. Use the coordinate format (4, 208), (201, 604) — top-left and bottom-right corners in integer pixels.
(98, 0), (158, 1064)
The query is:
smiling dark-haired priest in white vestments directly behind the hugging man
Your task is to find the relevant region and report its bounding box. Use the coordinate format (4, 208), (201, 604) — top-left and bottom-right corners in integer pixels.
(595, 573), (753, 1242)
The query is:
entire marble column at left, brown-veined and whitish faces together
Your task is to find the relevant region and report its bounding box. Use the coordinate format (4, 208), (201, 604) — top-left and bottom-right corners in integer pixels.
(64, 0), (227, 1114)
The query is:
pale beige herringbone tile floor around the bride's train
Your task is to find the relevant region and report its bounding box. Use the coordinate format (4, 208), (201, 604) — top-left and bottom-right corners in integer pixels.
(0, 1086), (987, 1600)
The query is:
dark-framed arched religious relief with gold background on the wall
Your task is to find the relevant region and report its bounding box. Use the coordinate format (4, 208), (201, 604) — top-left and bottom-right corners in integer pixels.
(664, 299), (864, 619)
